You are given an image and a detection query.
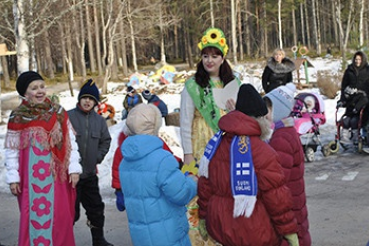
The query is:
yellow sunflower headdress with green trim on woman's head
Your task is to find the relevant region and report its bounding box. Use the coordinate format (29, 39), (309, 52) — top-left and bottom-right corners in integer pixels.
(197, 27), (228, 56)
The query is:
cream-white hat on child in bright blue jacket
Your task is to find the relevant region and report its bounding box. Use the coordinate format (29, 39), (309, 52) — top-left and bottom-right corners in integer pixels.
(126, 103), (162, 136)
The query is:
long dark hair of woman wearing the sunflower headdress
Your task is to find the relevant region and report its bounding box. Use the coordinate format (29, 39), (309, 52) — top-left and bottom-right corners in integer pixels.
(195, 47), (234, 88)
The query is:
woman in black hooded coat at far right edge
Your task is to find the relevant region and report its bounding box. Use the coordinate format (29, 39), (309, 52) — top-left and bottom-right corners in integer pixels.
(337, 51), (369, 145)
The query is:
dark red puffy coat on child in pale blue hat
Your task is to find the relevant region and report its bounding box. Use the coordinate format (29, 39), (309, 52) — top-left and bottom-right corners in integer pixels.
(269, 118), (311, 246)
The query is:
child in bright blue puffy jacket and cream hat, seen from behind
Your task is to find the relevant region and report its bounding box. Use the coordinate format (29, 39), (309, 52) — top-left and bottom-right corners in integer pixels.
(119, 103), (197, 246)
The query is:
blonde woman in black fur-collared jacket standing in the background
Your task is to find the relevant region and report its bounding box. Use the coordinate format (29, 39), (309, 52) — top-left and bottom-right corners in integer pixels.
(261, 48), (296, 93)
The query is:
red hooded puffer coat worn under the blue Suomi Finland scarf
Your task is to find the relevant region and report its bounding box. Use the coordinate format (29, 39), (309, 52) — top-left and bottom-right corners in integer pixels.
(198, 110), (297, 246)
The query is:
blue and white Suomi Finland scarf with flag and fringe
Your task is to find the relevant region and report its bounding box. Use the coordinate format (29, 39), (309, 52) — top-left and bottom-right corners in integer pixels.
(199, 130), (258, 218)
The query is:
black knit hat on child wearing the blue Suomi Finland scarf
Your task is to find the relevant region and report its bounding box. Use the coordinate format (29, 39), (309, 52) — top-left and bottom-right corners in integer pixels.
(236, 84), (268, 117)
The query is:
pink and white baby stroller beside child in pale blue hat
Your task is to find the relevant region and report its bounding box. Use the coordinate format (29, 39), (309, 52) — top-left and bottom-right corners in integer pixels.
(291, 92), (330, 162)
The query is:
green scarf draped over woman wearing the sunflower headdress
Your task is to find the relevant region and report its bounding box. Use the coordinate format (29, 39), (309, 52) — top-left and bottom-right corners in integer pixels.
(185, 77), (221, 132)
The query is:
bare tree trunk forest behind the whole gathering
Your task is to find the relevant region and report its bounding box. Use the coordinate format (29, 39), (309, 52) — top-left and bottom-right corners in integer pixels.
(0, 0), (369, 93)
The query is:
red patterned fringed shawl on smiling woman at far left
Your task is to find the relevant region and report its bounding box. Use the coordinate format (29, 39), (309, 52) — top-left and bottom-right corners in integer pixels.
(5, 98), (71, 180)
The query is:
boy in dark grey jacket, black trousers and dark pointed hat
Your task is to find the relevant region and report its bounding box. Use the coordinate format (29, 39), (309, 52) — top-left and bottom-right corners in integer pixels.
(68, 79), (113, 246)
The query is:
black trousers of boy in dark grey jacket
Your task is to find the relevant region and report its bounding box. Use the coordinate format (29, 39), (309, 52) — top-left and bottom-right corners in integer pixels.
(74, 175), (105, 228)
